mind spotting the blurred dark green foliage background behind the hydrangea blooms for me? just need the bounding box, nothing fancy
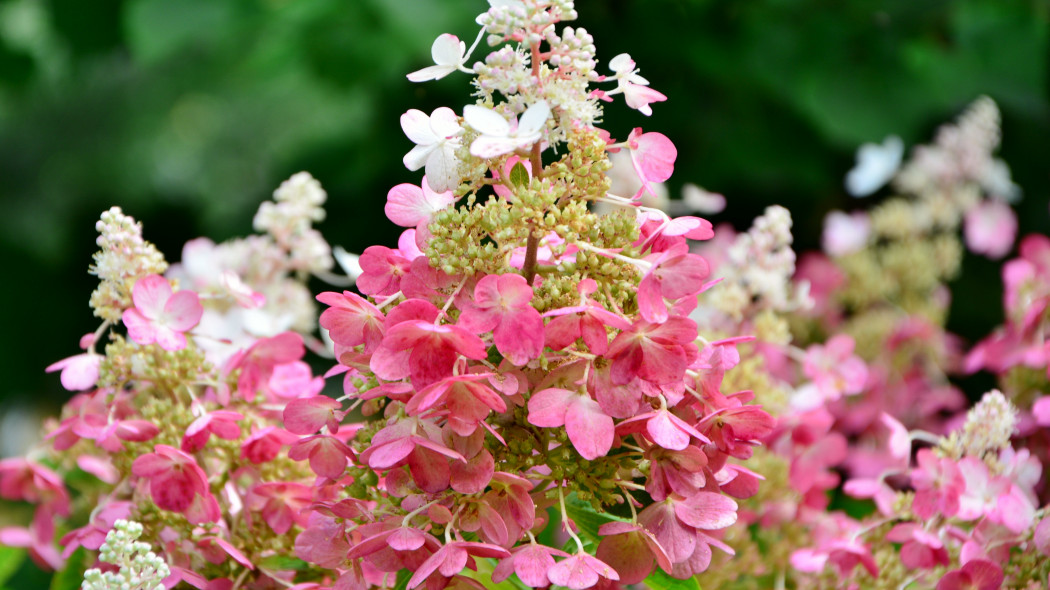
[0,0,1050,447]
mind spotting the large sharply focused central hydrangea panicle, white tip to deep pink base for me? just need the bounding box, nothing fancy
[296,2,772,588]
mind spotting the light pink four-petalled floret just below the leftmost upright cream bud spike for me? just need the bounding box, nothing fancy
[122,274,204,351]
